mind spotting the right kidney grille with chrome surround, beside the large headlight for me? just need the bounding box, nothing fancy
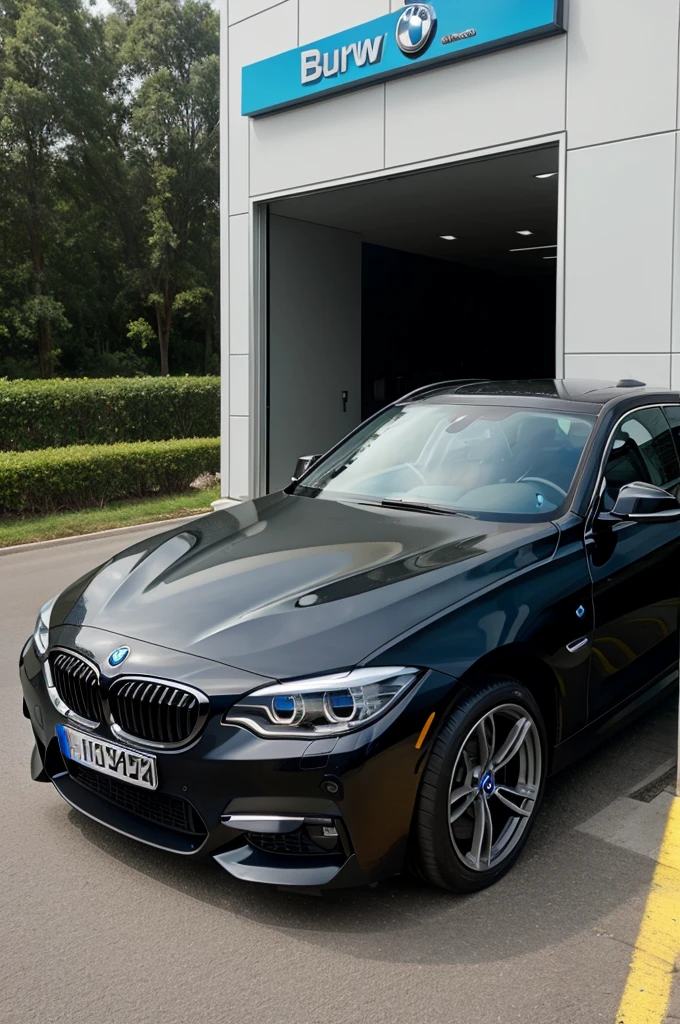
[105,676,210,751]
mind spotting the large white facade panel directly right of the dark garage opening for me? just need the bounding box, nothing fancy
[565,134,676,356]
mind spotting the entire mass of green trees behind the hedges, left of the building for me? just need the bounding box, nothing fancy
[0,0,219,377]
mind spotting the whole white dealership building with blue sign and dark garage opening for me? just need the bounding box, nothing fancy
[216,0,680,499]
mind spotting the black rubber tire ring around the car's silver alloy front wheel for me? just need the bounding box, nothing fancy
[417,676,548,892]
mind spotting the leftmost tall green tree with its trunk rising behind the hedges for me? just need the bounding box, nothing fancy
[0,0,113,377]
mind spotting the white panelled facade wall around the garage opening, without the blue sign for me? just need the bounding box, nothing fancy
[222,0,680,496]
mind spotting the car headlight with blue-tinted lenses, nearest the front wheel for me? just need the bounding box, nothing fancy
[222,667,420,738]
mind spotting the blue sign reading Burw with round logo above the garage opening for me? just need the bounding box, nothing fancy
[242,0,564,117]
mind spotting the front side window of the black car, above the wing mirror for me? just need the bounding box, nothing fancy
[603,409,680,512]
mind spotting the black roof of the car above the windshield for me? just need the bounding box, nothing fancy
[400,378,680,414]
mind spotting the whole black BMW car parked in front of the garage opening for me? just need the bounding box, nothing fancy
[20,381,680,892]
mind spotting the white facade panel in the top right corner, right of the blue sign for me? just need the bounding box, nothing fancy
[567,0,680,148]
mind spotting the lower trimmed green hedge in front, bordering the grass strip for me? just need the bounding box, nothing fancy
[0,438,219,514]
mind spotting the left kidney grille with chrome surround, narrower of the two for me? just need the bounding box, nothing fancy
[43,647,103,729]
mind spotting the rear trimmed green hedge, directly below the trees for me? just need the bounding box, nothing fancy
[0,377,220,452]
